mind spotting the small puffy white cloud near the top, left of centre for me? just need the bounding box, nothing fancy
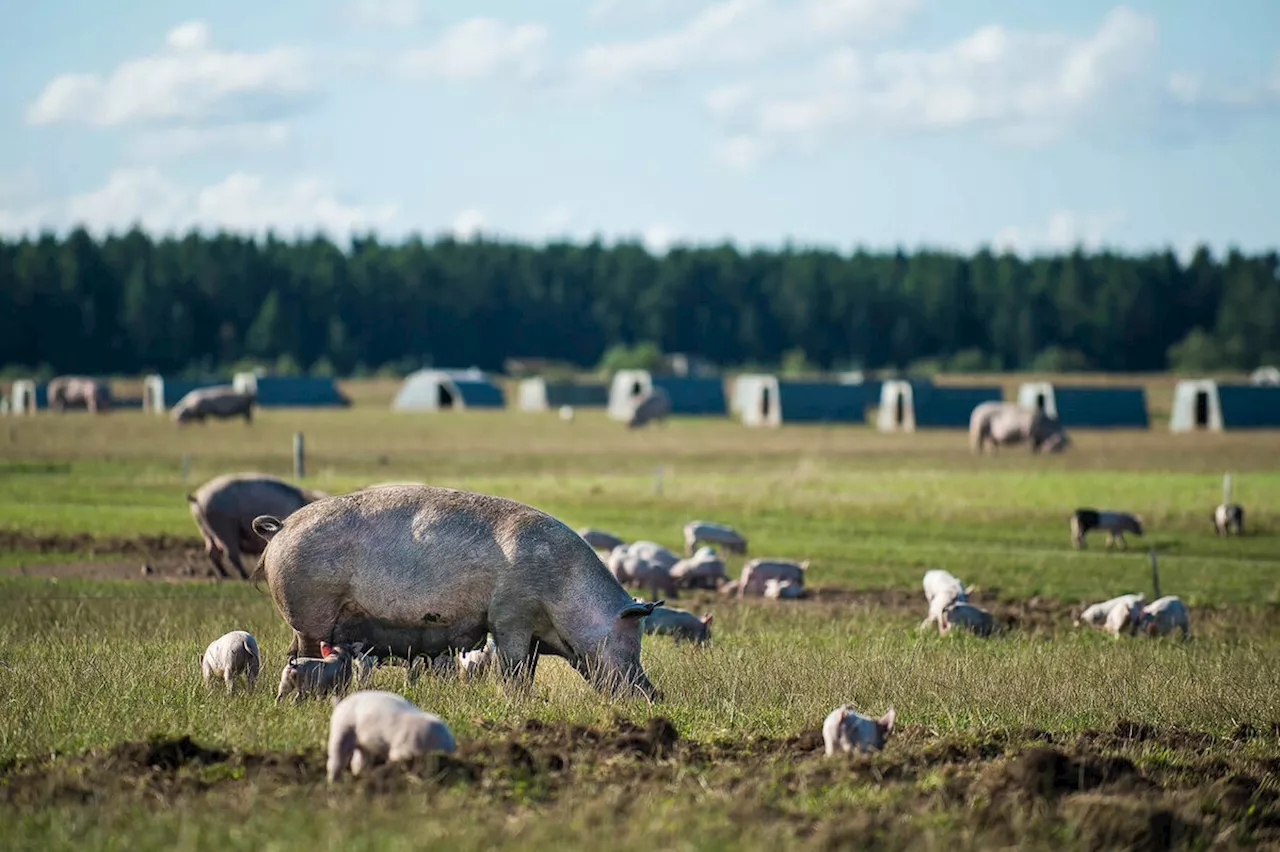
[399,18,548,79]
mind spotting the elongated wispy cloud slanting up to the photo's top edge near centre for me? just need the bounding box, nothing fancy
[571,0,918,87]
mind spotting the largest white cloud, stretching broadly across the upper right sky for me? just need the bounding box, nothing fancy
[705,6,1156,168]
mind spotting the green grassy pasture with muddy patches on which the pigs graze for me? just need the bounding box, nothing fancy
[0,384,1280,849]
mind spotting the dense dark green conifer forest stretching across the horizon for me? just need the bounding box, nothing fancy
[0,230,1280,375]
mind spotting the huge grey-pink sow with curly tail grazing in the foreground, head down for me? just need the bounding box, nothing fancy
[253,485,662,700]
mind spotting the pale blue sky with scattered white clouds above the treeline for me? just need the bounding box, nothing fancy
[0,0,1280,253]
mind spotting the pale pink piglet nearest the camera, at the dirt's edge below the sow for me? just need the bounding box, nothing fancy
[326,690,456,782]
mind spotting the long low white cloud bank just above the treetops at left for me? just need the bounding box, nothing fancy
[0,168,398,239]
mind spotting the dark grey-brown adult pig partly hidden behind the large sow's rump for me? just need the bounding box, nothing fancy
[187,473,326,580]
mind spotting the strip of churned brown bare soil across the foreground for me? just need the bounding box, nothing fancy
[0,716,1280,848]
